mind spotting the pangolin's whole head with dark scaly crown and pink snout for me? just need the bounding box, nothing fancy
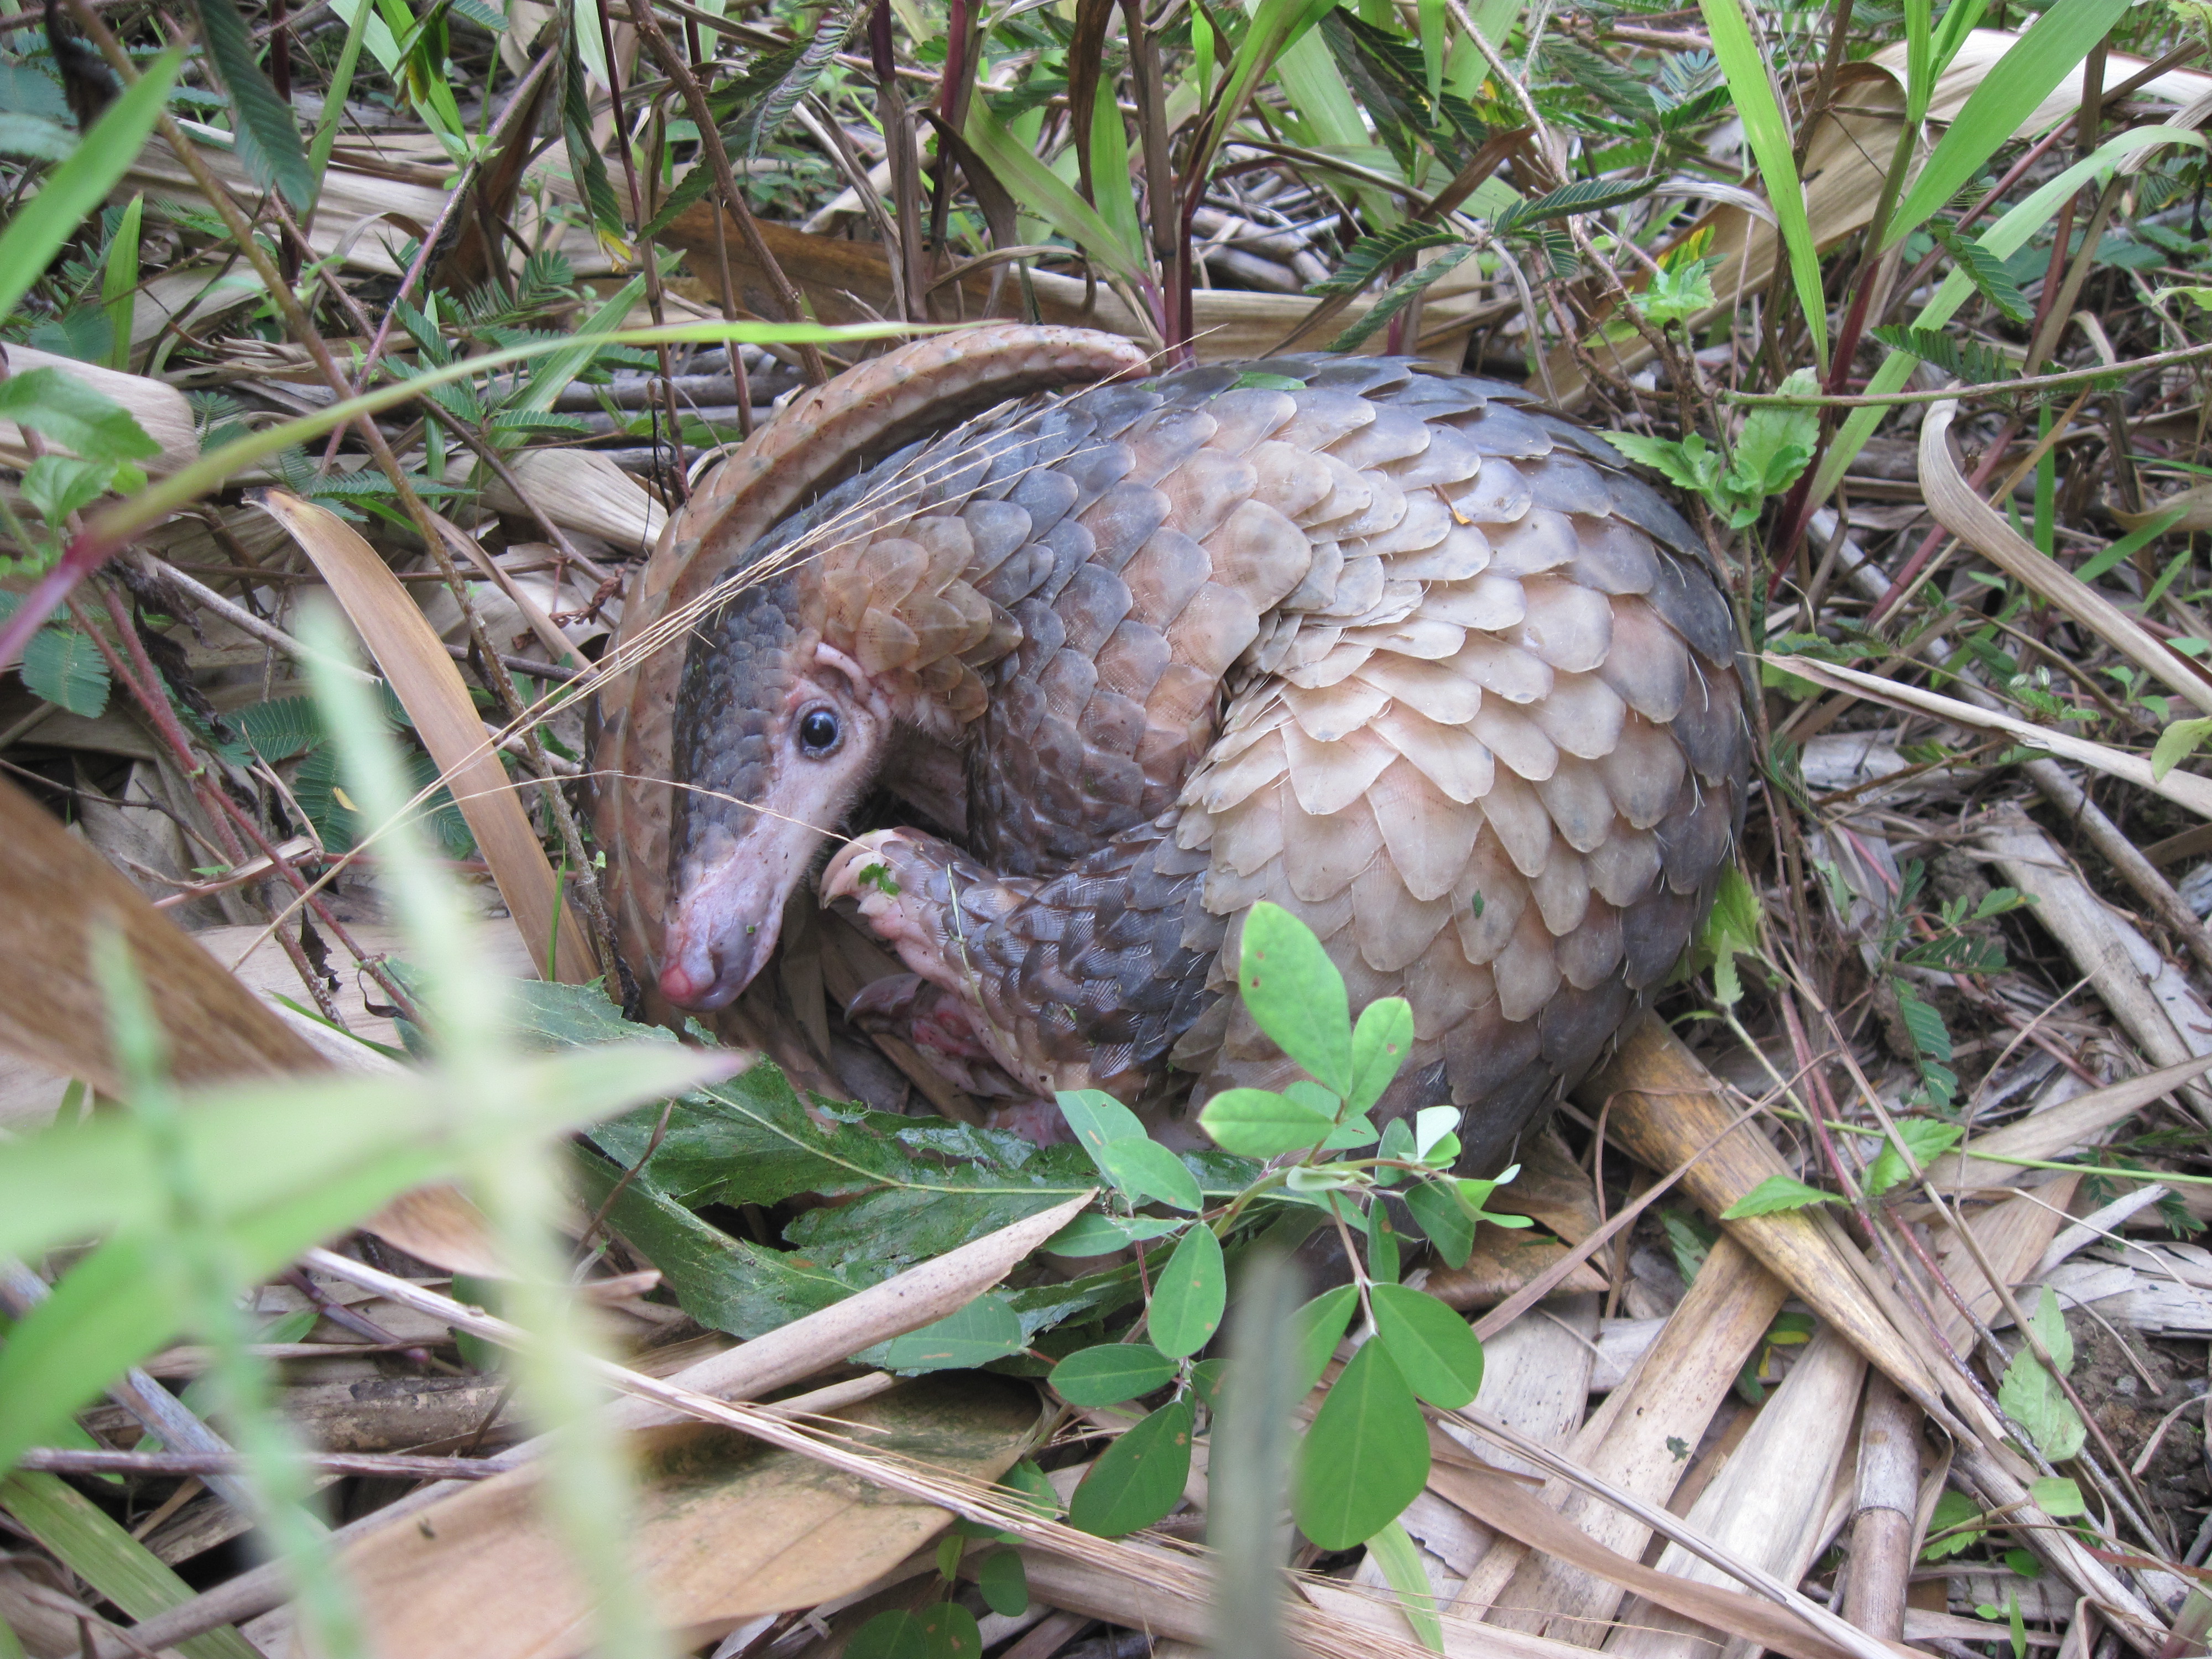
[661,566,894,1011]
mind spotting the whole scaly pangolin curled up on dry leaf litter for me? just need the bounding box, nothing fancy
[595,325,1750,1166]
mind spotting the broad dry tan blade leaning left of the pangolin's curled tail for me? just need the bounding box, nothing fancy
[261,489,599,984]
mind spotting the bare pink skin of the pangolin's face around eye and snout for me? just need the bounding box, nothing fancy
[659,644,898,1013]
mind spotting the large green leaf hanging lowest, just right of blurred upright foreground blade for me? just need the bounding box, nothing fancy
[1292,1340,1429,1551]
